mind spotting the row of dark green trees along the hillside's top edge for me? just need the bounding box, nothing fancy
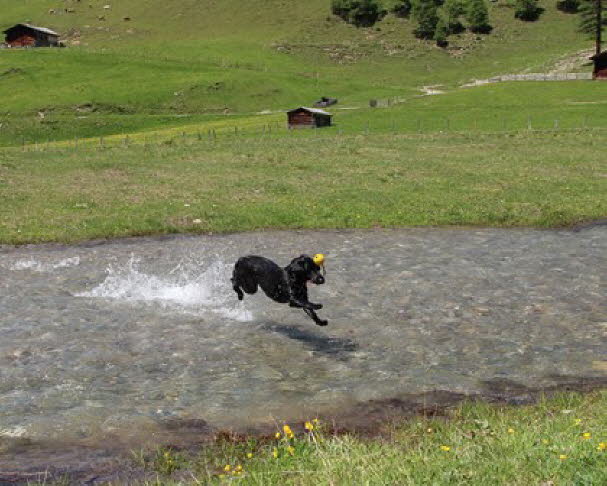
[331,0,607,46]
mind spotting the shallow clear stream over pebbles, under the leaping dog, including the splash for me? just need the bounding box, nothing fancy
[0,227,607,470]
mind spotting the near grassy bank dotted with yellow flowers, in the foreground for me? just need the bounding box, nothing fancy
[124,391,607,486]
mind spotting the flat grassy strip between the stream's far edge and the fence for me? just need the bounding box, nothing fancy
[0,130,607,244]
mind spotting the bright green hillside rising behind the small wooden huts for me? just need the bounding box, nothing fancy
[0,0,587,145]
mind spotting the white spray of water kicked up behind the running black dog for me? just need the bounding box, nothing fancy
[76,257,252,322]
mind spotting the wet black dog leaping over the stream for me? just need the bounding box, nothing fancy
[232,255,327,326]
